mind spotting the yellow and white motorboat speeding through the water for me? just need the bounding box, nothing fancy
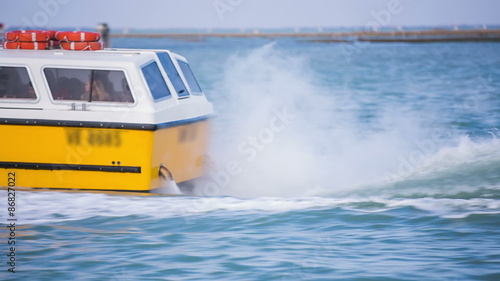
[0,30,214,192]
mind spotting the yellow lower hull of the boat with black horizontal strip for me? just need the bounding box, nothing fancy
[0,119,211,192]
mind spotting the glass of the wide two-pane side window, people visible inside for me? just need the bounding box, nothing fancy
[44,68,134,103]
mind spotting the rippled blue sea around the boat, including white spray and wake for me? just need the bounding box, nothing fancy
[0,38,500,281]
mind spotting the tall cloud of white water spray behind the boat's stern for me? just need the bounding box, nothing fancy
[197,44,500,197]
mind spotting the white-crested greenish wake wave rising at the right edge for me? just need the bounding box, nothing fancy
[355,137,500,199]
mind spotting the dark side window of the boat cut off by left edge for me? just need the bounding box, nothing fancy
[0,66,36,100]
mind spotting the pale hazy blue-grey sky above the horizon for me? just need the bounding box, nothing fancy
[0,0,500,30]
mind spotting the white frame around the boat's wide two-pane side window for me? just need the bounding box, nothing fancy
[40,64,138,107]
